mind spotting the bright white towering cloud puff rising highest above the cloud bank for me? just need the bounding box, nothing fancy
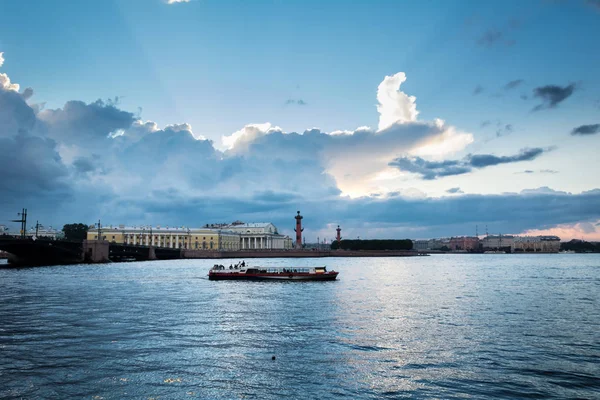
[377,72,419,131]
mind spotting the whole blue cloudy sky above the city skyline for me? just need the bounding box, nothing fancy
[0,0,600,241]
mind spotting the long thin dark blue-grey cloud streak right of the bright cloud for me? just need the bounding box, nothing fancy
[390,147,548,180]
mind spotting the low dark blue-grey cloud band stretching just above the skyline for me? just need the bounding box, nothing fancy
[116,188,600,238]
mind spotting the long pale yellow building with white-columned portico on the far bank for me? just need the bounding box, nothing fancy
[87,223,292,251]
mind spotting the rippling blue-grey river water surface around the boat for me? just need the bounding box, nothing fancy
[0,255,600,399]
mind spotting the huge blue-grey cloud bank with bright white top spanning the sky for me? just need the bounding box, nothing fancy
[0,52,600,237]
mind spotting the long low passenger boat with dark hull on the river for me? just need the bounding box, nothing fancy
[208,265,339,281]
